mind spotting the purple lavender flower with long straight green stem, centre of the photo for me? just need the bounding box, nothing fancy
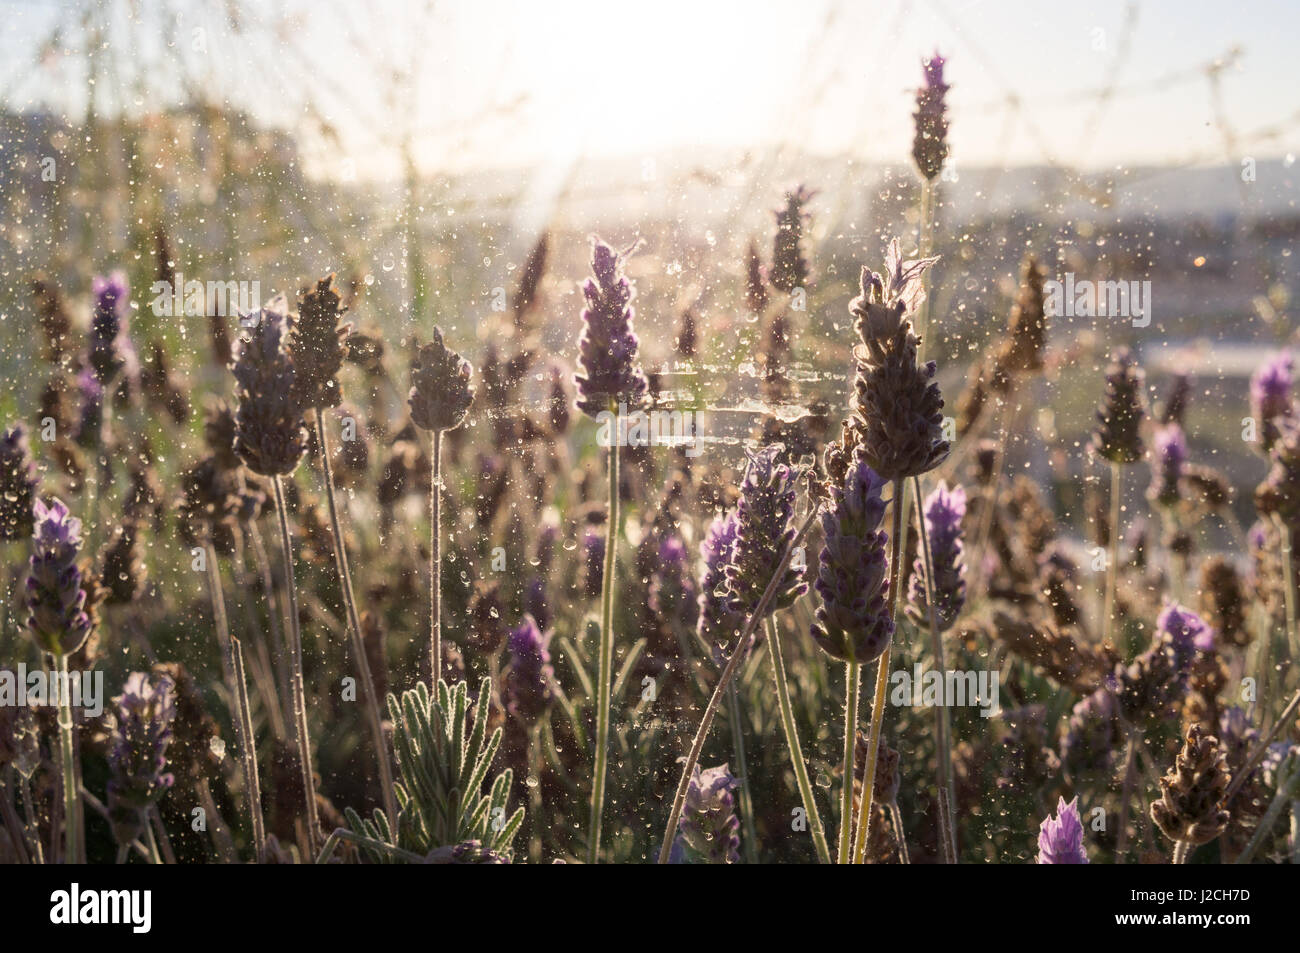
[573,239,650,863]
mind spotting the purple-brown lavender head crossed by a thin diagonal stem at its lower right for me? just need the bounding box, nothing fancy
[725,445,807,615]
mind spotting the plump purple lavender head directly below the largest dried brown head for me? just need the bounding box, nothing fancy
[811,460,894,663]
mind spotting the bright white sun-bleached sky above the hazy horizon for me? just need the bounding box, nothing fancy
[0,0,1300,174]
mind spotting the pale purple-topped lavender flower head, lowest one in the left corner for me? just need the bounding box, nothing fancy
[108,672,176,844]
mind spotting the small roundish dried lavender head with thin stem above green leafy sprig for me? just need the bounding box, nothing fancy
[408,328,475,685]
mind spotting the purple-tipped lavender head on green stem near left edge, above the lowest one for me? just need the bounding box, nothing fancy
[27,499,91,657]
